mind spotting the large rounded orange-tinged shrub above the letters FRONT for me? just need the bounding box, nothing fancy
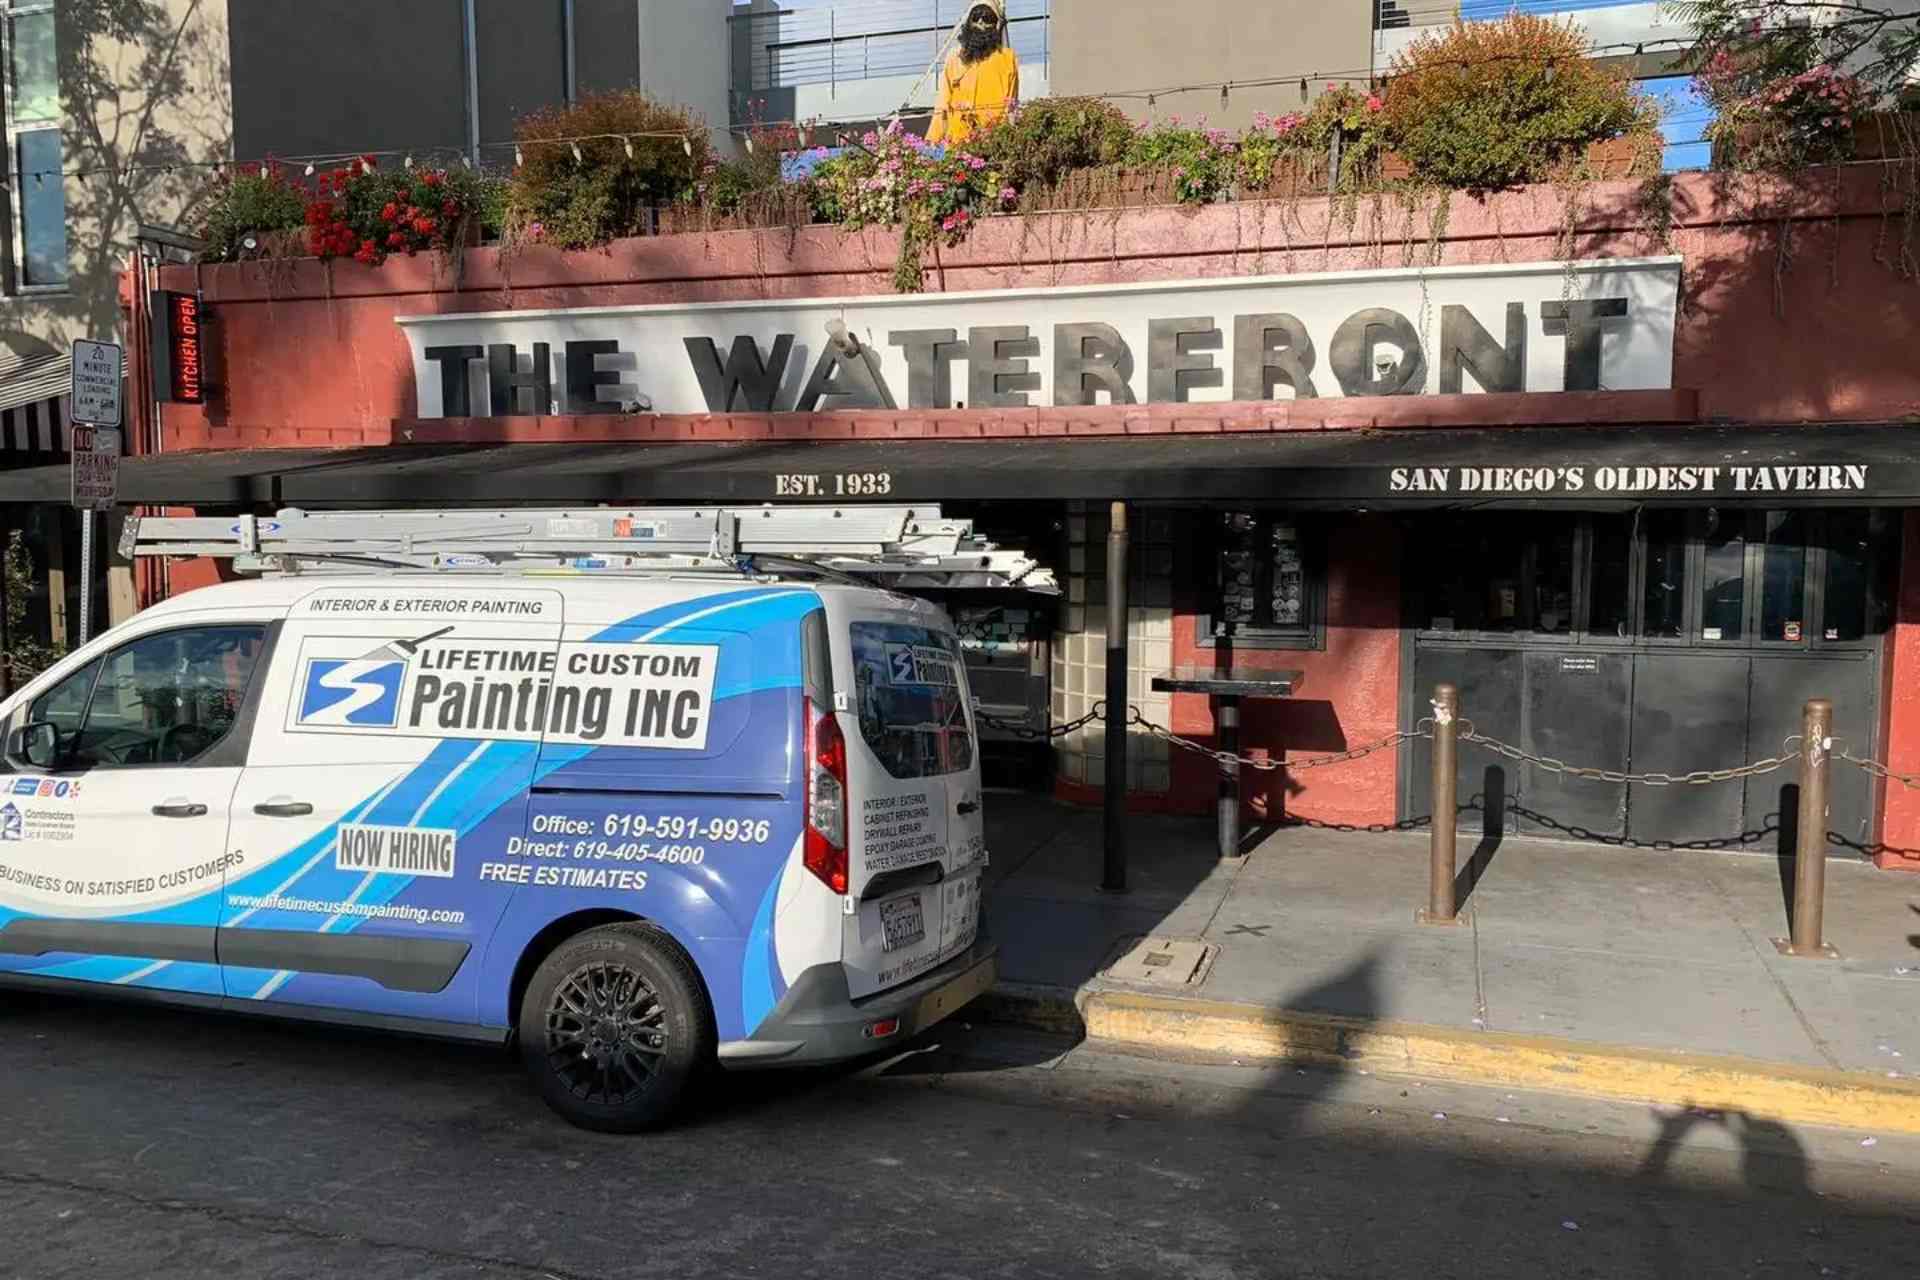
[1382,13,1659,190]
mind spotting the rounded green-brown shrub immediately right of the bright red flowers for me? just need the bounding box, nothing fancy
[505,90,712,249]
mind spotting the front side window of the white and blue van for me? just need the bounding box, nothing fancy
[50,626,267,768]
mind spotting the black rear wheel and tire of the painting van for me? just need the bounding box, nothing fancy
[518,923,714,1134]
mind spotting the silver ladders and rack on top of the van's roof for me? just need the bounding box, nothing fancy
[121,505,1058,593]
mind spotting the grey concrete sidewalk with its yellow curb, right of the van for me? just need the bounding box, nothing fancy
[985,794,1920,1132]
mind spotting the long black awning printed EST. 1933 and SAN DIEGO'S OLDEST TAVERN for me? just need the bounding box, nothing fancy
[0,424,1920,509]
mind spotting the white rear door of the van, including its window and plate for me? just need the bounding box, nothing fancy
[843,612,981,998]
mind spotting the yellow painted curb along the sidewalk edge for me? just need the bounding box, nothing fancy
[1006,990,1920,1134]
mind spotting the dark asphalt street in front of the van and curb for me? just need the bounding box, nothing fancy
[0,996,1920,1280]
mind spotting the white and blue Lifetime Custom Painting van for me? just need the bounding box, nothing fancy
[0,510,1021,1130]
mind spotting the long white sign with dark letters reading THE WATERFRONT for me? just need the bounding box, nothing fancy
[399,257,1680,418]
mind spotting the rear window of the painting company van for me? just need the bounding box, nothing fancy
[851,622,973,777]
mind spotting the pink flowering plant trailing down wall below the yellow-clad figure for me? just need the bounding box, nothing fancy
[810,121,1020,294]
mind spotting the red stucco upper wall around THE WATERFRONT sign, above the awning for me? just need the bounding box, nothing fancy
[165,165,1920,449]
